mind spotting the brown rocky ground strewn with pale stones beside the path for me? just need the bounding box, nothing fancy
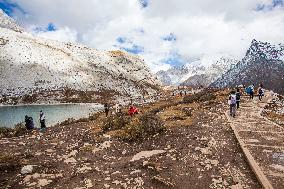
[0,91,266,189]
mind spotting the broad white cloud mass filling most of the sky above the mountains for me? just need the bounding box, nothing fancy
[10,0,284,72]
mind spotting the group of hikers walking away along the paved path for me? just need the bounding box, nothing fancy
[228,84,264,117]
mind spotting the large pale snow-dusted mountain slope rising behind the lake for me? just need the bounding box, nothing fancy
[0,12,159,103]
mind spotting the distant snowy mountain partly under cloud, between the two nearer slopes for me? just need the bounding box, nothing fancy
[156,57,237,86]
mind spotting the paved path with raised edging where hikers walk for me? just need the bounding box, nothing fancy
[226,94,284,189]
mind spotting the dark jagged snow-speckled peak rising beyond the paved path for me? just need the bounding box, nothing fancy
[211,39,284,93]
